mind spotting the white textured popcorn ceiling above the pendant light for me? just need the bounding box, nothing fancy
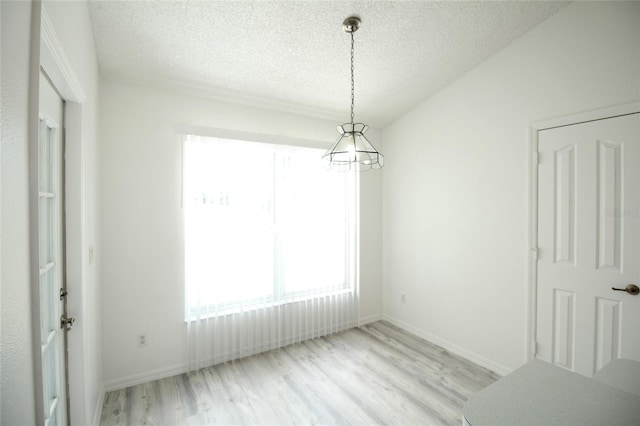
[89,0,566,128]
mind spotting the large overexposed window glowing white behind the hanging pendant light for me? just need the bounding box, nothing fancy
[184,136,357,317]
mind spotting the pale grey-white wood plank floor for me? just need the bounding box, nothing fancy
[101,321,499,426]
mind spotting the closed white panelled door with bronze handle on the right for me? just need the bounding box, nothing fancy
[536,114,640,377]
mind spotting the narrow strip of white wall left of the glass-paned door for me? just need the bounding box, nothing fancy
[0,1,36,425]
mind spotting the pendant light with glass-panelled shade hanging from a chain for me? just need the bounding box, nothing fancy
[322,16,384,171]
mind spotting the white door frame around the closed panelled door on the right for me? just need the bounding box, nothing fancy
[525,101,640,361]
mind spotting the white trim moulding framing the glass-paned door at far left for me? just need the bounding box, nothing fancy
[36,1,89,424]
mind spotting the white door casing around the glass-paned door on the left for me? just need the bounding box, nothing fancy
[29,2,88,424]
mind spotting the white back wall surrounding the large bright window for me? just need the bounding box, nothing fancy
[100,81,382,388]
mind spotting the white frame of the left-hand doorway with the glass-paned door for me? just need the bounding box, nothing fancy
[29,2,86,424]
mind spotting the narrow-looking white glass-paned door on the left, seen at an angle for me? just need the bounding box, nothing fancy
[38,73,67,426]
